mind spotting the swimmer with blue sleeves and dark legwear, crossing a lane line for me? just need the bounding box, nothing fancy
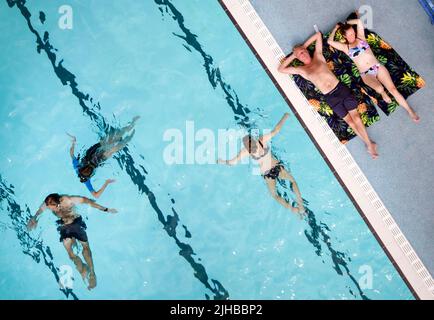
[68,116,140,198]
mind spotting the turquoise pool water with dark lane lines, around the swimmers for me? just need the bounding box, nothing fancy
[0,0,413,299]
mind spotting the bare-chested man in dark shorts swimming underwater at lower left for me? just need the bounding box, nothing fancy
[27,193,117,290]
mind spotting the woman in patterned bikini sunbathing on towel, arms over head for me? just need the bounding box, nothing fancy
[328,19,420,123]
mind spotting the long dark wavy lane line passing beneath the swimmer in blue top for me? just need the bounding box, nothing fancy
[6,0,229,300]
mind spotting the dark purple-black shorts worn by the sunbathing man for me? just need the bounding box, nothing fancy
[324,82,358,119]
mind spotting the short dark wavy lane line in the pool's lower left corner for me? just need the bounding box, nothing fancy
[0,174,79,300]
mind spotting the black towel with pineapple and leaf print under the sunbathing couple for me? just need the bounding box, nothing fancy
[292,23,425,143]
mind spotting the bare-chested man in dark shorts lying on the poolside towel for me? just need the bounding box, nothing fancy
[279,32,378,159]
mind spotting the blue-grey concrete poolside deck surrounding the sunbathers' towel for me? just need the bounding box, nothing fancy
[250,0,434,275]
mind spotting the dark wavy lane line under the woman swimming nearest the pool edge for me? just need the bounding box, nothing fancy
[154,0,369,299]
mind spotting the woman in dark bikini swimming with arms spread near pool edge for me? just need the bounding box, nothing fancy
[218,113,305,217]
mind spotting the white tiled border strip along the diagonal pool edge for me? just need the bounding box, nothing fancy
[222,0,434,300]
